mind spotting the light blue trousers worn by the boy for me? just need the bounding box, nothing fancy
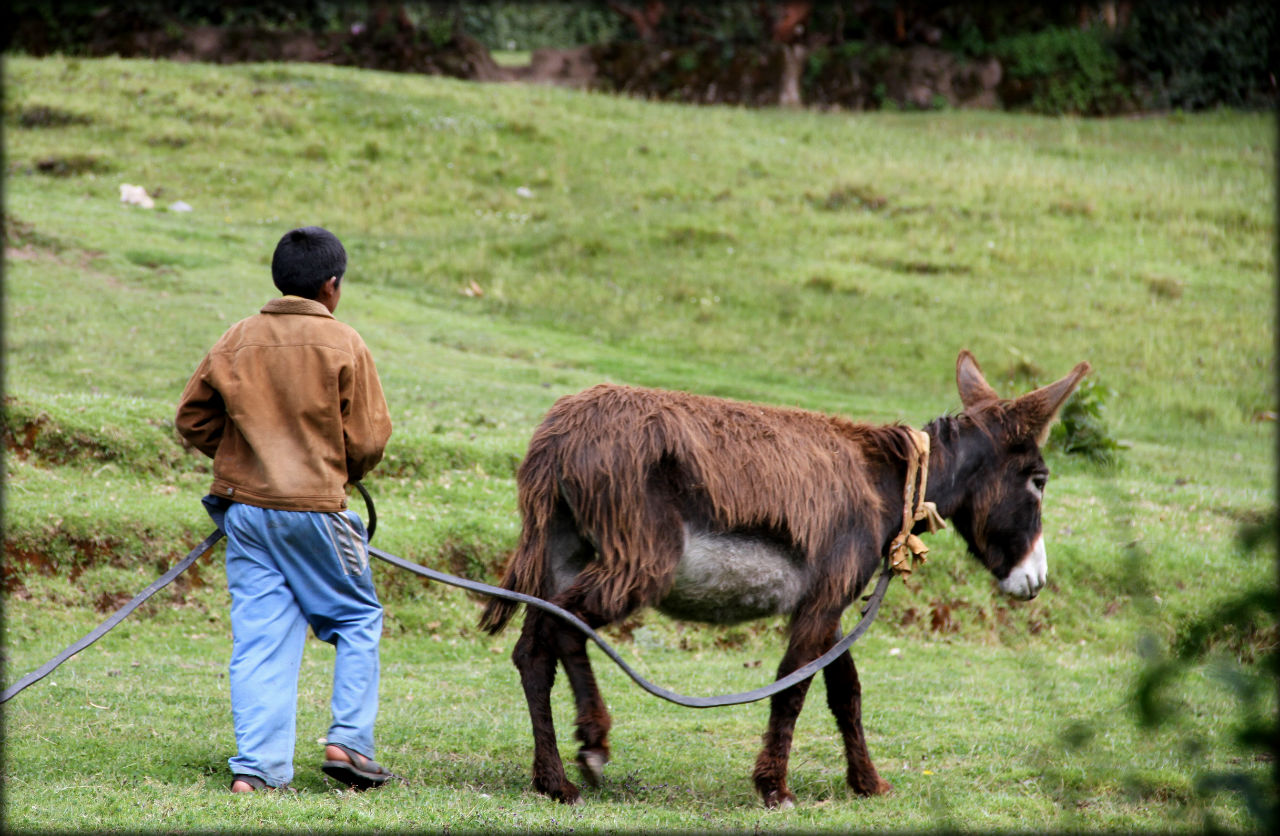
[223,503,383,786]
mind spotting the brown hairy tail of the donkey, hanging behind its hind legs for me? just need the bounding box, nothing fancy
[480,451,559,634]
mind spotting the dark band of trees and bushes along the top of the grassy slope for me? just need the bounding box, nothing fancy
[4,0,1277,117]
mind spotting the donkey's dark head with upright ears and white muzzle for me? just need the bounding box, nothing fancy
[925,351,1089,600]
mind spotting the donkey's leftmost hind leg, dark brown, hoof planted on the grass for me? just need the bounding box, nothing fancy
[511,608,581,804]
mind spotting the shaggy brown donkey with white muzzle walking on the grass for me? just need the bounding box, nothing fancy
[480,351,1091,808]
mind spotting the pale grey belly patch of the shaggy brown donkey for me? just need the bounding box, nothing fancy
[658,527,809,623]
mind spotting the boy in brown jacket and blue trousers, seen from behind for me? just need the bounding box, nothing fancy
[175,227,394,792]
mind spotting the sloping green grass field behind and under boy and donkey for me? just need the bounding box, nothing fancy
[4,58,1277,831]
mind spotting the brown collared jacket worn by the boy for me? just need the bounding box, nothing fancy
[175,296,392,511]
